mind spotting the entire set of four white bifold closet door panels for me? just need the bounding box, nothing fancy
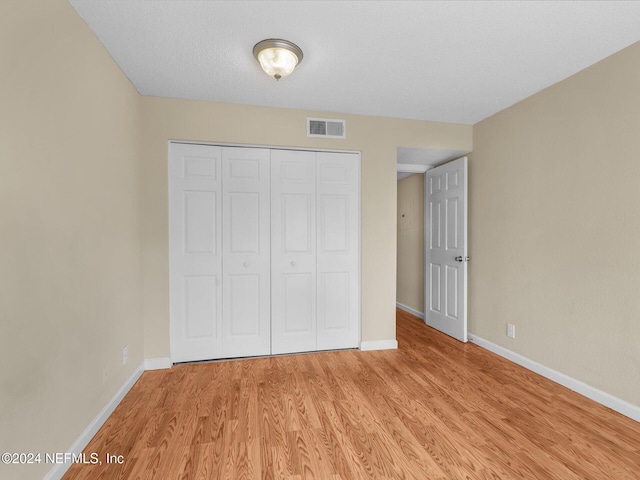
[169,143,360,362]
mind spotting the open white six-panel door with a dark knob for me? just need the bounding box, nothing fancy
[425,157,469,342]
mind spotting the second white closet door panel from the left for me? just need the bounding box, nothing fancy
[222,147,271,358]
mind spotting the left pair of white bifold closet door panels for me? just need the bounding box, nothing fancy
[169,143,271,362]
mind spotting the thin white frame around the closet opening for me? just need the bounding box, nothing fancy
[165,139,362,364]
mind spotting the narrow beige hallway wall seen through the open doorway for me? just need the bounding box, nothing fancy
[396,173,424,313]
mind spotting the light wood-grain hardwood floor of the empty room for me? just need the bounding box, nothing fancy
[64,311,640,480]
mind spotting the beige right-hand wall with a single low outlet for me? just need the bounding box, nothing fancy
[469,44,640,406]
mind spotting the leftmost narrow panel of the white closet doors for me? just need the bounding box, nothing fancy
[169,143,222,362]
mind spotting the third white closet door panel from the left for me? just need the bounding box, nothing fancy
[271,150,317,354]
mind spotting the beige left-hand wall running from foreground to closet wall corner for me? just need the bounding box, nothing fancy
[0,0,143,479]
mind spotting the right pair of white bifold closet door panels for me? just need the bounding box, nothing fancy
[271,150,360,354]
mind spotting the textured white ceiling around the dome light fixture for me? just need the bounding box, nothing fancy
[70,0,640,124]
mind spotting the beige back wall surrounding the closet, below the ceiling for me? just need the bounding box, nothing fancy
[141,97,471,358]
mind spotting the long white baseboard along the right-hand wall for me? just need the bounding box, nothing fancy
[469,334,640,422]
